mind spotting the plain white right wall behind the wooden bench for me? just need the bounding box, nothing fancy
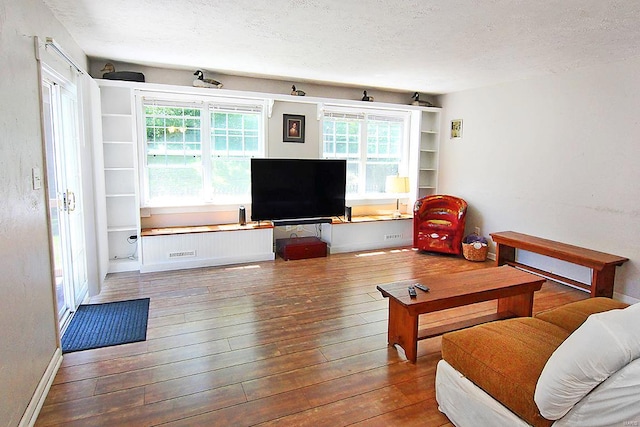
[439,58,640,299]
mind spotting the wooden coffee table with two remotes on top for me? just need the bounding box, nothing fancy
[377,266,545,363]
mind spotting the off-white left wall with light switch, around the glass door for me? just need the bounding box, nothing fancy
[0,0,85,426]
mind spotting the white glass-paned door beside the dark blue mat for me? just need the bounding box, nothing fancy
[42,68,87,329]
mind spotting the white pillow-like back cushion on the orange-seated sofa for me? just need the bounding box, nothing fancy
[534,304,640,420]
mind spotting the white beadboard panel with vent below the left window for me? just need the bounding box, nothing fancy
[140,228,275,272]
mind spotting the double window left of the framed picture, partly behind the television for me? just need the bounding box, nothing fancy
[142,98,264,206]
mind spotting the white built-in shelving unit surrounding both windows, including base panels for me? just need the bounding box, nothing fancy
[98,80,441,273]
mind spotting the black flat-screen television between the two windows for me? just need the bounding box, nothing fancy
[251,159,347,221]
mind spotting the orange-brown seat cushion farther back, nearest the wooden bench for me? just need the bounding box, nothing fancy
[536,297,629,333]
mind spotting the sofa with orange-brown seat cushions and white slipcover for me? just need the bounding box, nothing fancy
[436,298,640,427]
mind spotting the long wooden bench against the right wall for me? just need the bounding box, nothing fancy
[491,231,629,298]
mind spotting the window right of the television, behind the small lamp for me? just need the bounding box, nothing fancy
[322,109,409,198]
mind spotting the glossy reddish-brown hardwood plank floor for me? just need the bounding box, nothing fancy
[36,248,588,426]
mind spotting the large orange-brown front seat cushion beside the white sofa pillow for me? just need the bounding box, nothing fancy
[442,317,569,426]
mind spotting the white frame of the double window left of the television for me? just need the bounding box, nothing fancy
[135,90,269,209]
